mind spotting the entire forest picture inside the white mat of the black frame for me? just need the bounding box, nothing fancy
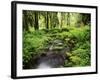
[22,10,91,69]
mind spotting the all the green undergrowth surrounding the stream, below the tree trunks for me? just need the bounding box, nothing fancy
[23,26,91,67]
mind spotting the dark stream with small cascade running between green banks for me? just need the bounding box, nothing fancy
[24,39,69,69]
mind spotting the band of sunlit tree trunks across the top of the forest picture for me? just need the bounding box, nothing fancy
[23,10,91,31]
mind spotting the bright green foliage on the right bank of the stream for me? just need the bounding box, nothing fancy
[65,26,91,67]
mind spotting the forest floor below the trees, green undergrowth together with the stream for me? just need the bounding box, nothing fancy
[23,26,91,69]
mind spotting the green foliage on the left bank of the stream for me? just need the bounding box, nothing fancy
[23,31,47,63]
